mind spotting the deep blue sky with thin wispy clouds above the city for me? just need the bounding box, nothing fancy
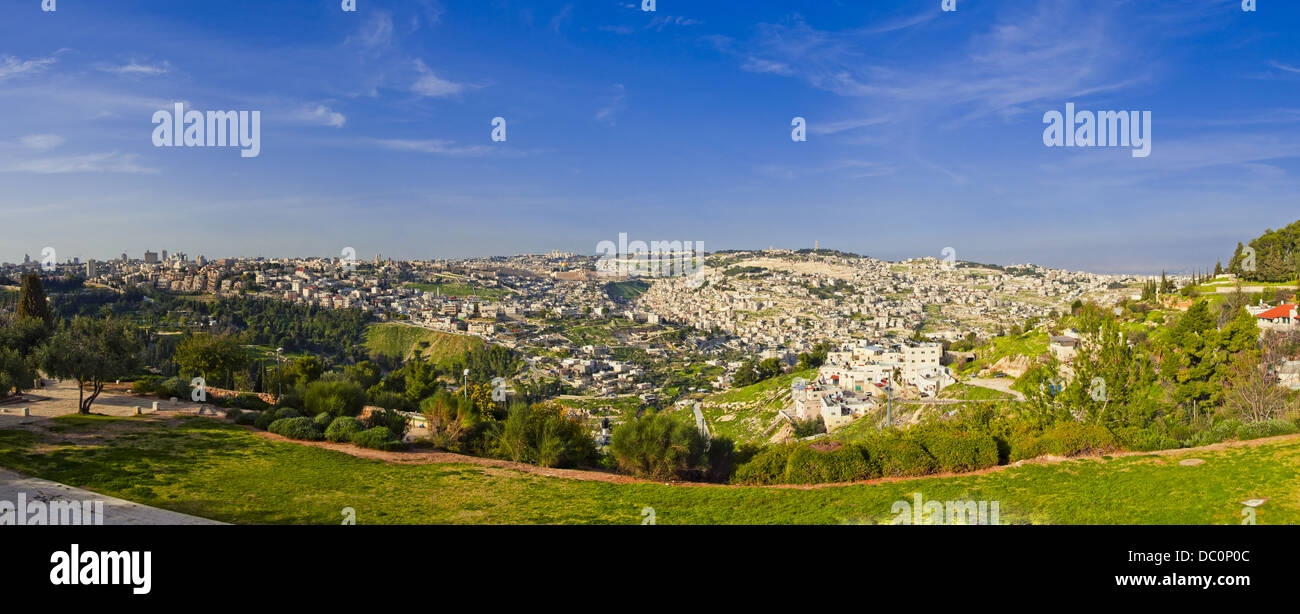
[0,0,1300,272]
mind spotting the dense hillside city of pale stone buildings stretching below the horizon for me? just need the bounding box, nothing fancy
[0,245,1147,413]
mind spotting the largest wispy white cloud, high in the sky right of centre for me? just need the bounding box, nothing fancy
[733,0,1148,120]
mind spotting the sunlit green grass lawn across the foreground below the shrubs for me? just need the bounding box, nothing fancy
[0,416,1300,524]
